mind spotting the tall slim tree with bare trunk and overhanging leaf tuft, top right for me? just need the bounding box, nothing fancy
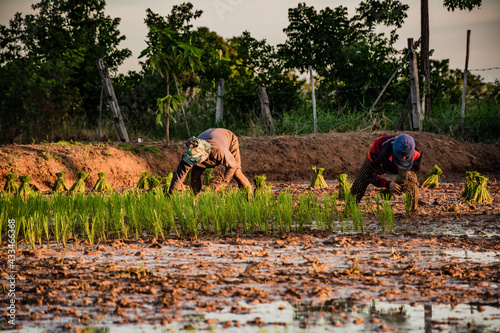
[420,0,482,115]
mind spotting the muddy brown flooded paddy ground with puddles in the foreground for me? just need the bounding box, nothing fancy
[1,181,500,332]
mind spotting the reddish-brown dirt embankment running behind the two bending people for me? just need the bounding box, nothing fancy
[0,131,500,191]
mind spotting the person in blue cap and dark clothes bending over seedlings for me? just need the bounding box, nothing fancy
[351,134,422,202]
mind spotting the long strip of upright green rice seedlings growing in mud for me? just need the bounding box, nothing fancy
[0,188,402,247]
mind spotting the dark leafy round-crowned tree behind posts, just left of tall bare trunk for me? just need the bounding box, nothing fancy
[279,0,408,112]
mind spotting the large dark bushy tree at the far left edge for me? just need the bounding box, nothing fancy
[0,0,131,140]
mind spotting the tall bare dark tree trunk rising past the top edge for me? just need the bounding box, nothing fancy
[420,0,432,115]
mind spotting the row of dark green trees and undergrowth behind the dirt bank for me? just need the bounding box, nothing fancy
[0,0,500,144]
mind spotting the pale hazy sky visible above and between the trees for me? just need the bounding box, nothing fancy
[0,0,500,81]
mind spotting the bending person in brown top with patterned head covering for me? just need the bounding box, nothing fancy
[169,128,251,194]
